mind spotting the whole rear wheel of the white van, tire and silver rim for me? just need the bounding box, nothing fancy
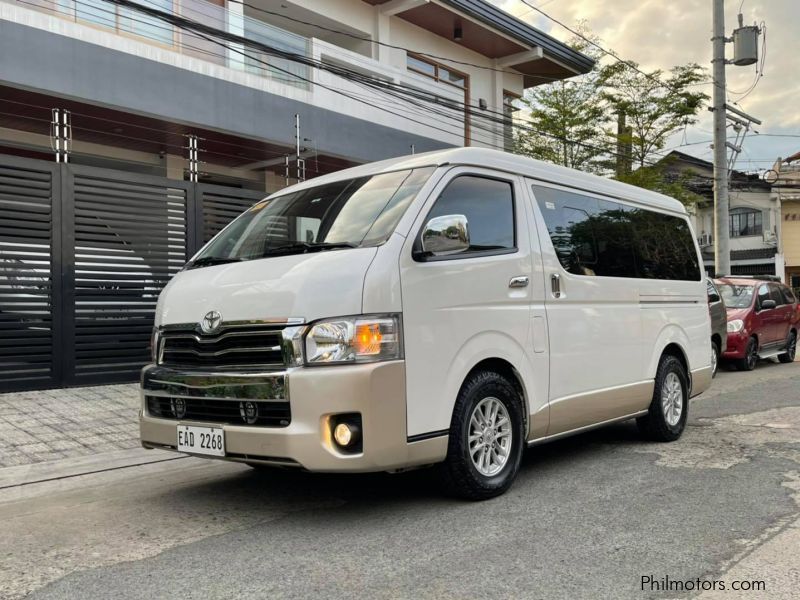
[636,354,689,442]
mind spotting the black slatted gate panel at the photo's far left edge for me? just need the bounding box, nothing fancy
[0,160,54,390]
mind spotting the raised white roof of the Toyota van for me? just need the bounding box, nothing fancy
[275,148,686,214]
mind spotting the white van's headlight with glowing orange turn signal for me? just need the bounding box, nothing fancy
[305,315,403,365]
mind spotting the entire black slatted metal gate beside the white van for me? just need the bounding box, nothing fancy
[0,155,265,391]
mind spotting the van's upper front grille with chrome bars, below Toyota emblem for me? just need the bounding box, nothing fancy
[158,322,286,370]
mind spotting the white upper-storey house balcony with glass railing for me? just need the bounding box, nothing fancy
[0,0,468,152]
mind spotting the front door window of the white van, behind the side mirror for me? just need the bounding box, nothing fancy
[427,175,516,256]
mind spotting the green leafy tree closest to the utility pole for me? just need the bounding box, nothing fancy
[598,62,708,168]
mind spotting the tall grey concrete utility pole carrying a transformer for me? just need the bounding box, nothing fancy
[711,0,731,277]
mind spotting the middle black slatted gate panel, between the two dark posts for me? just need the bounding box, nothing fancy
[73,169,187,382]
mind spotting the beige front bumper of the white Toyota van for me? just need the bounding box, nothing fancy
[139,361,447,472]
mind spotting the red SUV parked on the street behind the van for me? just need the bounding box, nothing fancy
[715,277,800,371]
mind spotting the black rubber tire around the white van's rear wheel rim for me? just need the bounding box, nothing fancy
[636,354,689,442]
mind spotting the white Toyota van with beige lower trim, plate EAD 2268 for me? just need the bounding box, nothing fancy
[141,148,711,499]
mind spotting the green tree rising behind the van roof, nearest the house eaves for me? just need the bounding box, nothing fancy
[514,24,607,171]
